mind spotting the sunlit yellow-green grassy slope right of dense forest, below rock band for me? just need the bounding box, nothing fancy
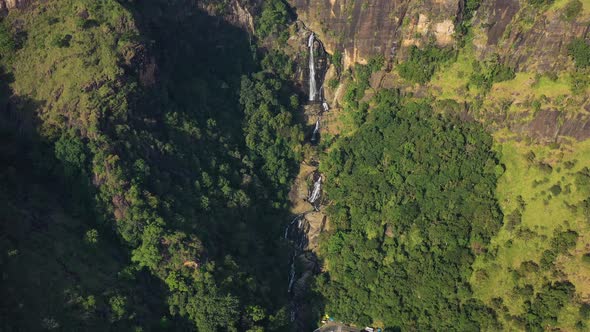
[471,141,590,328]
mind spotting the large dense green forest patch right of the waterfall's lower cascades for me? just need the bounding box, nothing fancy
[317,93,501,330]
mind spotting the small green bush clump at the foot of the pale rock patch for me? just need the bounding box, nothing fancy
[398,44,454,84]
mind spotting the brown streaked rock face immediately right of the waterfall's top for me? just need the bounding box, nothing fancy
[289,0,461,66]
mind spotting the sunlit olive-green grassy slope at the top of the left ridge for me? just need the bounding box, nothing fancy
[6,0,137,135]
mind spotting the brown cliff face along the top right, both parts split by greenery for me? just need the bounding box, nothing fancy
[288,0,589,71]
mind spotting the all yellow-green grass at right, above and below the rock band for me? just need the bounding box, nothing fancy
[429,0,590,330]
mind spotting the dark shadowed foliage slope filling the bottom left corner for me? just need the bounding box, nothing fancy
[0,128,173,331]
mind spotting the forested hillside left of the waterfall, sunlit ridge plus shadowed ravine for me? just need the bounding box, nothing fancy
[0,0,302,331]
